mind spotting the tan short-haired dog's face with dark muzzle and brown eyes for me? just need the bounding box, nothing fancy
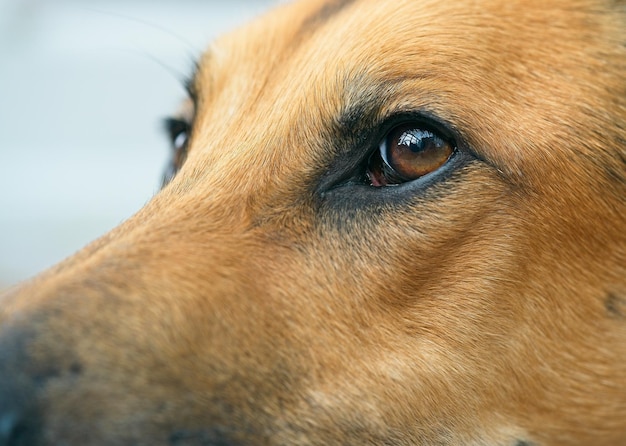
[0,0,626,446]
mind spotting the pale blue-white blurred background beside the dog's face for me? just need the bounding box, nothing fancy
[0,0,275,289]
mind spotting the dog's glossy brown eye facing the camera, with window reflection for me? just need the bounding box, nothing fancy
[367,123,455,187]
